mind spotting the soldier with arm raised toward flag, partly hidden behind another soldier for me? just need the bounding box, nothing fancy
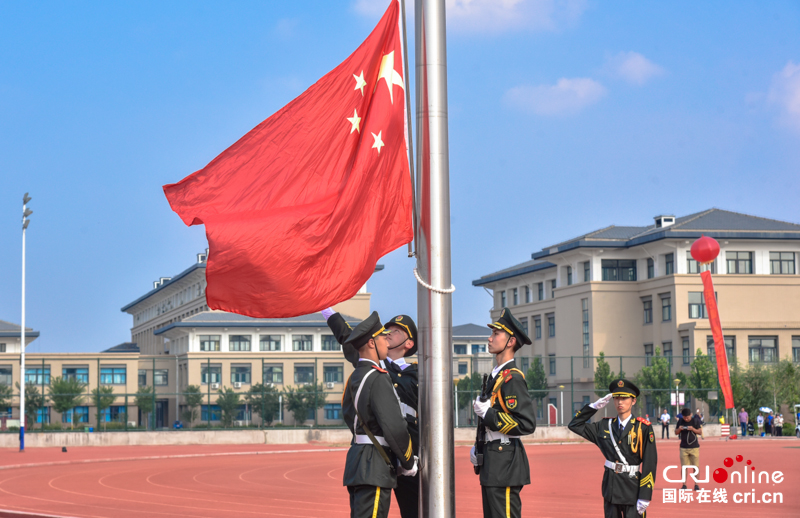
[322,309,419,518]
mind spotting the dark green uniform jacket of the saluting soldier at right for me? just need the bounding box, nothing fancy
[569,405,658,505]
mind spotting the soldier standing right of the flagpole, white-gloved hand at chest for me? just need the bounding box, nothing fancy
[470,308,536,518]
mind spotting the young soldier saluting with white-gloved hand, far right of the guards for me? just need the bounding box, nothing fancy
[569,379,658,518]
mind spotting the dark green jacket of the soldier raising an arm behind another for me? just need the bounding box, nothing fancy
[328,313,419,455]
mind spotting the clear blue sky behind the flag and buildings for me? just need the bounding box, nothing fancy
[0,0,800,352]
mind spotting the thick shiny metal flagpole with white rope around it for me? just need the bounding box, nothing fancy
[415,0,455,518]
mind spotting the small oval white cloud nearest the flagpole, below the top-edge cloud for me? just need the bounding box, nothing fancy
[504,77,606,115]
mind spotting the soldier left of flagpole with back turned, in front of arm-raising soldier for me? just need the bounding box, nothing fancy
[342,312,417,518]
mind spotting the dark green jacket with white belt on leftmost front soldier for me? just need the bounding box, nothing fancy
[342,360,414,488]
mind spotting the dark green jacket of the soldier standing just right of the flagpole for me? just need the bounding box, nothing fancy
[481,360,536,487]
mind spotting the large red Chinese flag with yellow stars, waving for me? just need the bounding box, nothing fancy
[164,1,413,318]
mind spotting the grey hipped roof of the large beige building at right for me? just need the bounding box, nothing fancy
[472,208,800,286]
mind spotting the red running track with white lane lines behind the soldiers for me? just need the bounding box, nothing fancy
[0,438,800,518]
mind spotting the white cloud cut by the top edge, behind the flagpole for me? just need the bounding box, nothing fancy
[353,0,587,33]
